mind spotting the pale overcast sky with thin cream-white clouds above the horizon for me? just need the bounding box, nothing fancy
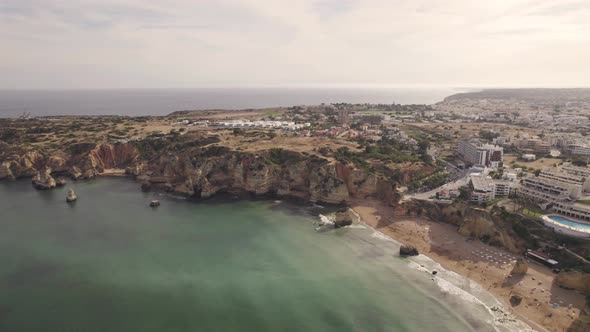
[0,0,590,89]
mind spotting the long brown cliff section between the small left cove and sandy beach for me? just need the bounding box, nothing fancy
[139,151,395,204]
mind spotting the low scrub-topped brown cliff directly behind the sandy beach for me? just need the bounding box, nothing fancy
[398,201,526,253]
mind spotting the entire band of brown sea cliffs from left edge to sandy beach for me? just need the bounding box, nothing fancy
[0,144,396,204]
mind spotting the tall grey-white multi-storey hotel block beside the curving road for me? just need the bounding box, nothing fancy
[457,138,504,168]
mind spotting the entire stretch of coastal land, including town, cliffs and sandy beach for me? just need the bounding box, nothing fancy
[0,90,590,331]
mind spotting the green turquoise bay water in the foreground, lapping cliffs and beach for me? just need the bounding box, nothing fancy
[0,179,504,332]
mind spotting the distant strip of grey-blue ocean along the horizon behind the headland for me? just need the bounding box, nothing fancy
[0,88,463,118]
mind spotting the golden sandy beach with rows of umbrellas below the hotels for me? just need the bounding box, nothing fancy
[352,200,585,331]
